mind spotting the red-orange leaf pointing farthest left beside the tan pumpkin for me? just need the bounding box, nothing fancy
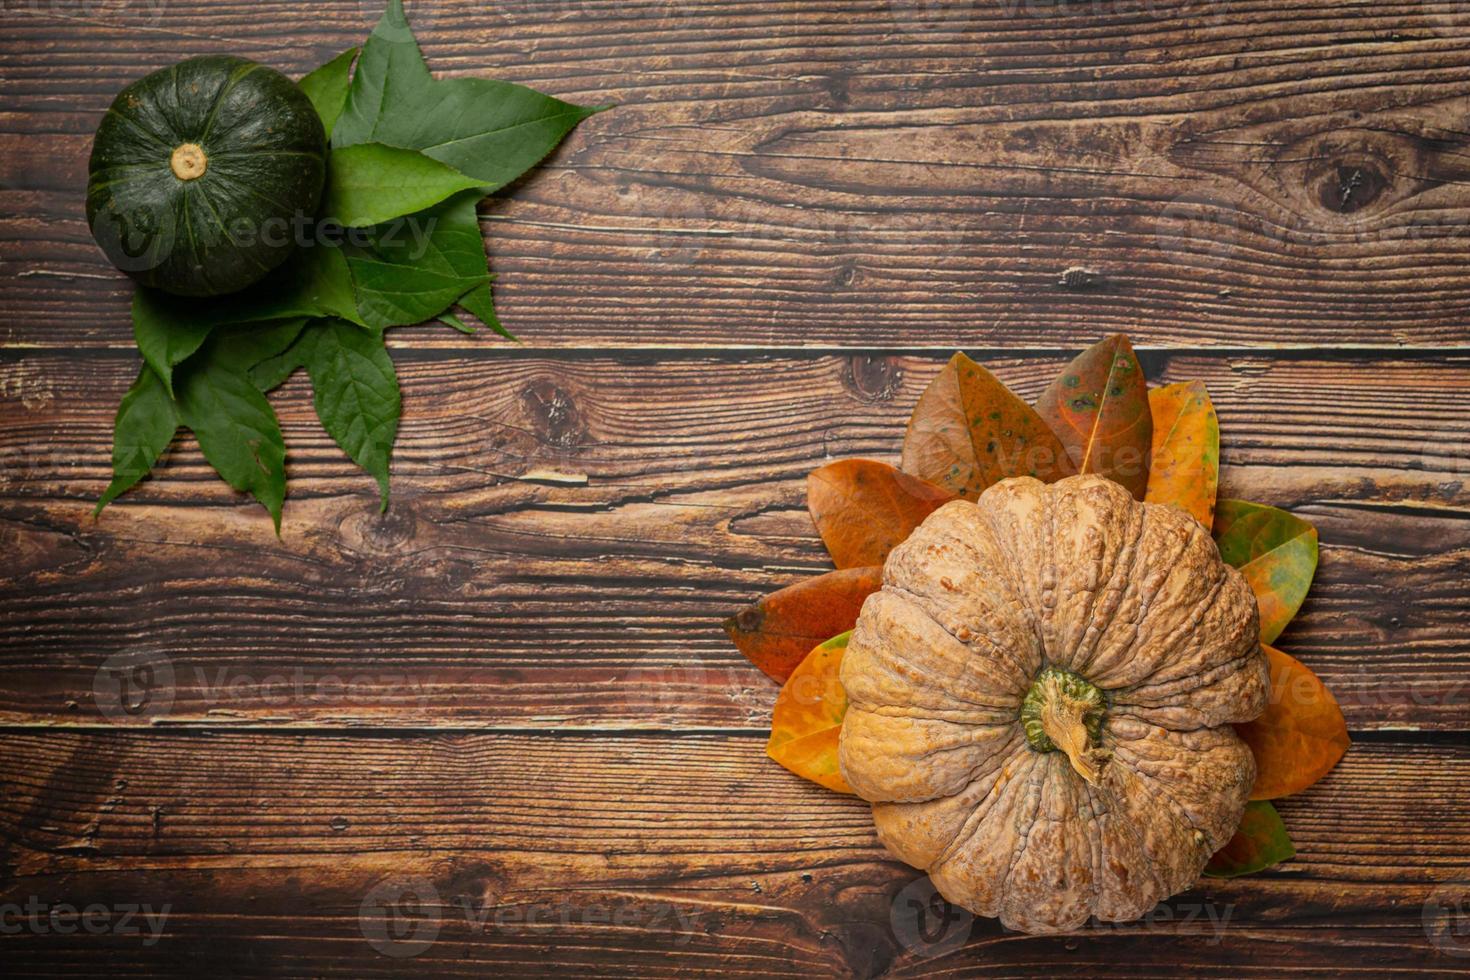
[725,566,883,682]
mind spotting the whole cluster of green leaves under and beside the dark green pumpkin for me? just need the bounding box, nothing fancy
[97,0,598,532]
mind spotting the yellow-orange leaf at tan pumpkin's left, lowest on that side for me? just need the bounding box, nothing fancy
[766,632,853,793]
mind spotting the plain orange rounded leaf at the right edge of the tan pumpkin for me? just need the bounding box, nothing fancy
[1235,644,1349,799]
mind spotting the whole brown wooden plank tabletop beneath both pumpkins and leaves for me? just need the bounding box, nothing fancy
[0,0,1470,977]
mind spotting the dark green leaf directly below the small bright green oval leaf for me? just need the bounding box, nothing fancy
[347,191,490,329]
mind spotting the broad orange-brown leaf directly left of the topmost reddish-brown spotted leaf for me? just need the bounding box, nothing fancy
[903,354,1076,500]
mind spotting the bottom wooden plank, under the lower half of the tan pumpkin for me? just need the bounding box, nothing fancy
[0,732,1470,977]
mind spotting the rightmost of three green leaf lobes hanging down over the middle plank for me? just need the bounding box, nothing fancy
[306,320,403,510]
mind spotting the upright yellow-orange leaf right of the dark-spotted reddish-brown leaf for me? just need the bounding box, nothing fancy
[1144,381,1220,527]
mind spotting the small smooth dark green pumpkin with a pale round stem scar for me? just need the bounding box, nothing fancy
[87,54,326,297]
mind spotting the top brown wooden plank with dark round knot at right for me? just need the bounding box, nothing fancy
[0,0,1470,348]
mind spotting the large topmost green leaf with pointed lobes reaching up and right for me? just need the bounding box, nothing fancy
[332,0,600,190]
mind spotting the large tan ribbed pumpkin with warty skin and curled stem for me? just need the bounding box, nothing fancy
[839,476,1269,933]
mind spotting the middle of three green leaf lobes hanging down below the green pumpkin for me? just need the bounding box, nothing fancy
[178,344,285,533]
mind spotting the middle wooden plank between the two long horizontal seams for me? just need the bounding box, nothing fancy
[0,353,1470,730]
